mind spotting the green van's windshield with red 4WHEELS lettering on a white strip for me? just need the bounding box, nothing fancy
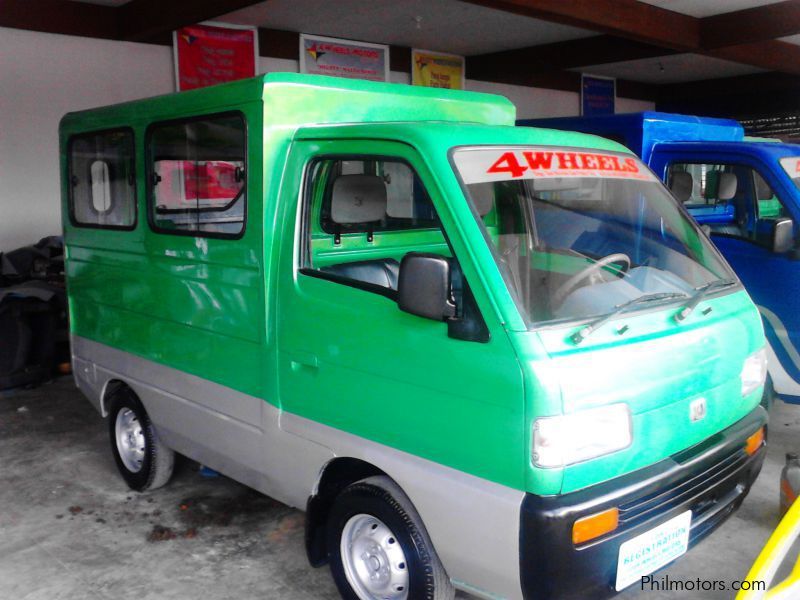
[453,147,734,324]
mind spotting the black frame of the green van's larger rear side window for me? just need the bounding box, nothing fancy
[144,110,250,240]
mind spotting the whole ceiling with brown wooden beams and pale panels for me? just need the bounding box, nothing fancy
[0,0,800,109]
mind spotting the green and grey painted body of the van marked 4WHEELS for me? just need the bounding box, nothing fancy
[60,74,765,598]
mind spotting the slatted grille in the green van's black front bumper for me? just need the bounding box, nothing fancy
[619,448,748,529]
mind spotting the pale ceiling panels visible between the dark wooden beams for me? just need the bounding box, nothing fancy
[216,0,800,84]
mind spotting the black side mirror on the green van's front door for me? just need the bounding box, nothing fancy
[397,252,456,321]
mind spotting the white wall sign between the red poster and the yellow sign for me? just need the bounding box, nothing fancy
[300,33,389,81]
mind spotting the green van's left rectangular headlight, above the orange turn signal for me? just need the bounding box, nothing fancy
[532,404,633,468]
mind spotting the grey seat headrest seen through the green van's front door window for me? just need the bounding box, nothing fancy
[331,175,387,225]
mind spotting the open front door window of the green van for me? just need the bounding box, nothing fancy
[301,157,451,293]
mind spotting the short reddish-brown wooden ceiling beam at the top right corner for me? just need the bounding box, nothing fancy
[700,0,800,49]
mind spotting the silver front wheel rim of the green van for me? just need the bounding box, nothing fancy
[339,514,408,600]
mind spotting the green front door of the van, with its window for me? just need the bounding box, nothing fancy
[277,140,526,489]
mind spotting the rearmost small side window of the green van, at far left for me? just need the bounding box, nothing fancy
[68,130,136,229]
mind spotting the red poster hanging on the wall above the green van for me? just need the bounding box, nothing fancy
[174,25,258,91]
